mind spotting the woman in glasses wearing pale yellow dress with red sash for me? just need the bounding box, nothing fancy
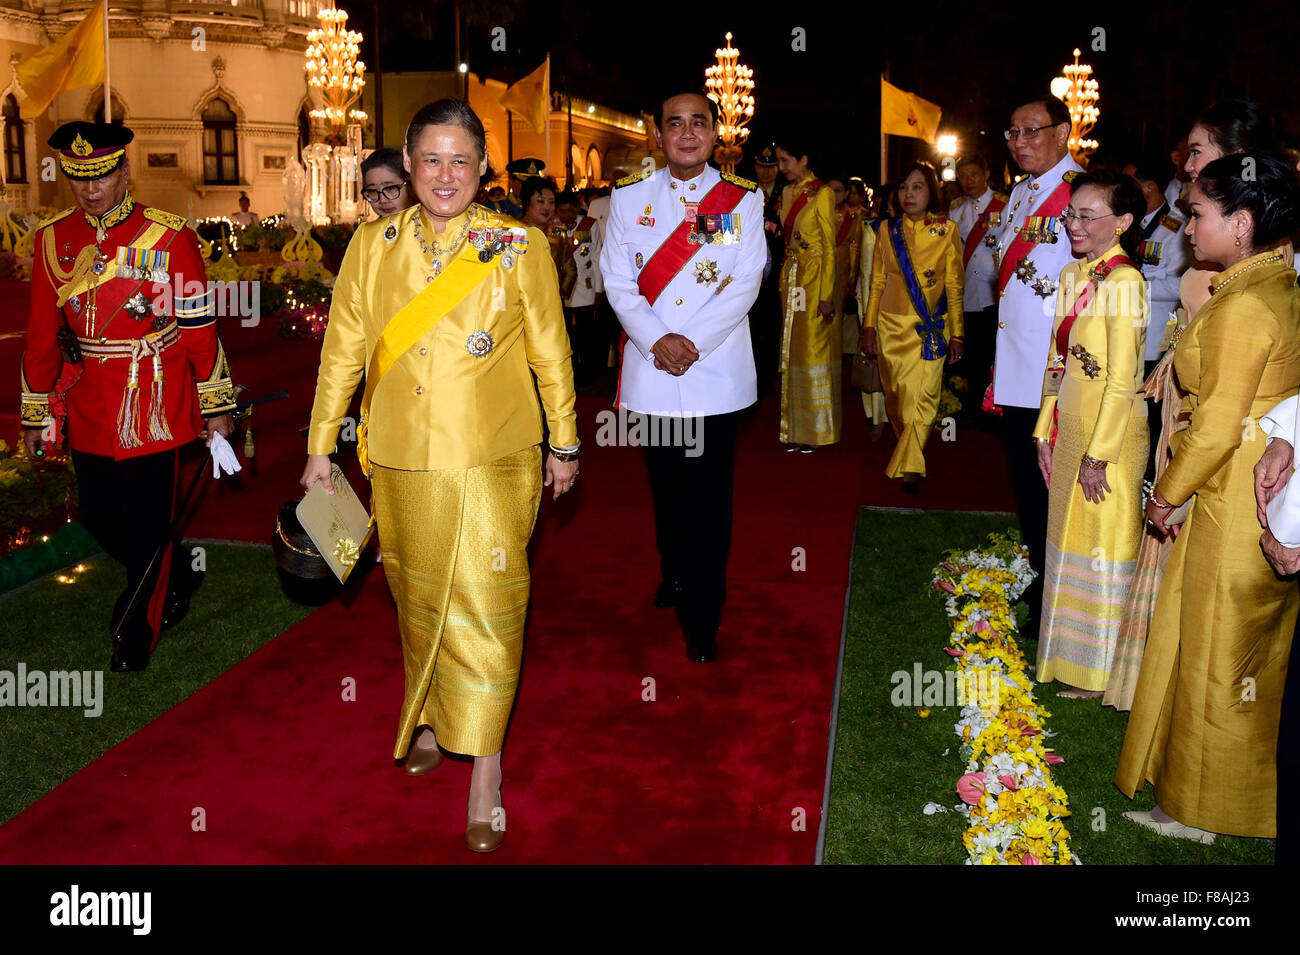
[1034,170,1151,699]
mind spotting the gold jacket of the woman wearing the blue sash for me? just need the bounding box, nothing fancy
[863,216,966,348]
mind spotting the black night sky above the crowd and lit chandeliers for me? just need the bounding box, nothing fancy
[356,0,1300,182]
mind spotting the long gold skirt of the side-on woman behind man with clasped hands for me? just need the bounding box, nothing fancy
[780,256,844,446]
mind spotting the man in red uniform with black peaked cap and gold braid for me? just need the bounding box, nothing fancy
[22,122,235,672]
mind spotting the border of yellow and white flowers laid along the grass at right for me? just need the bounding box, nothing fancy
[933,534,1078,865]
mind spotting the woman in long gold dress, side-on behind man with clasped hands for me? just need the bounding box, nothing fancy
[776,140,841,453]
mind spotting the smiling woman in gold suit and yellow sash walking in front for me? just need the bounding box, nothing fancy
[302,99,579,852]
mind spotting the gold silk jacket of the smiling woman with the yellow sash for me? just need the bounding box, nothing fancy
[307,205,577,470]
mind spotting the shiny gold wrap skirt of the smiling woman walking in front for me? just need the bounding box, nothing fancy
[372,447,542,759]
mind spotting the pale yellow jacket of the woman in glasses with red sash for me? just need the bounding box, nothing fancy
[1034,243,1147,461]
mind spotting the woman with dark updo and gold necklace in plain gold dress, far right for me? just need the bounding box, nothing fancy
[1115,153,1300,842]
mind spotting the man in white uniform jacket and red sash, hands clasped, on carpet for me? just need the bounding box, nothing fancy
[599,94,767,663]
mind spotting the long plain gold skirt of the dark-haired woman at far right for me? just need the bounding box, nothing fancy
[1115,433,1300,838]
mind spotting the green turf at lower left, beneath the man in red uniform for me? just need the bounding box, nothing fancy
[0,542,311,824]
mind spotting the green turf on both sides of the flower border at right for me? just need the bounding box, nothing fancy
[824,508,1273,865]
